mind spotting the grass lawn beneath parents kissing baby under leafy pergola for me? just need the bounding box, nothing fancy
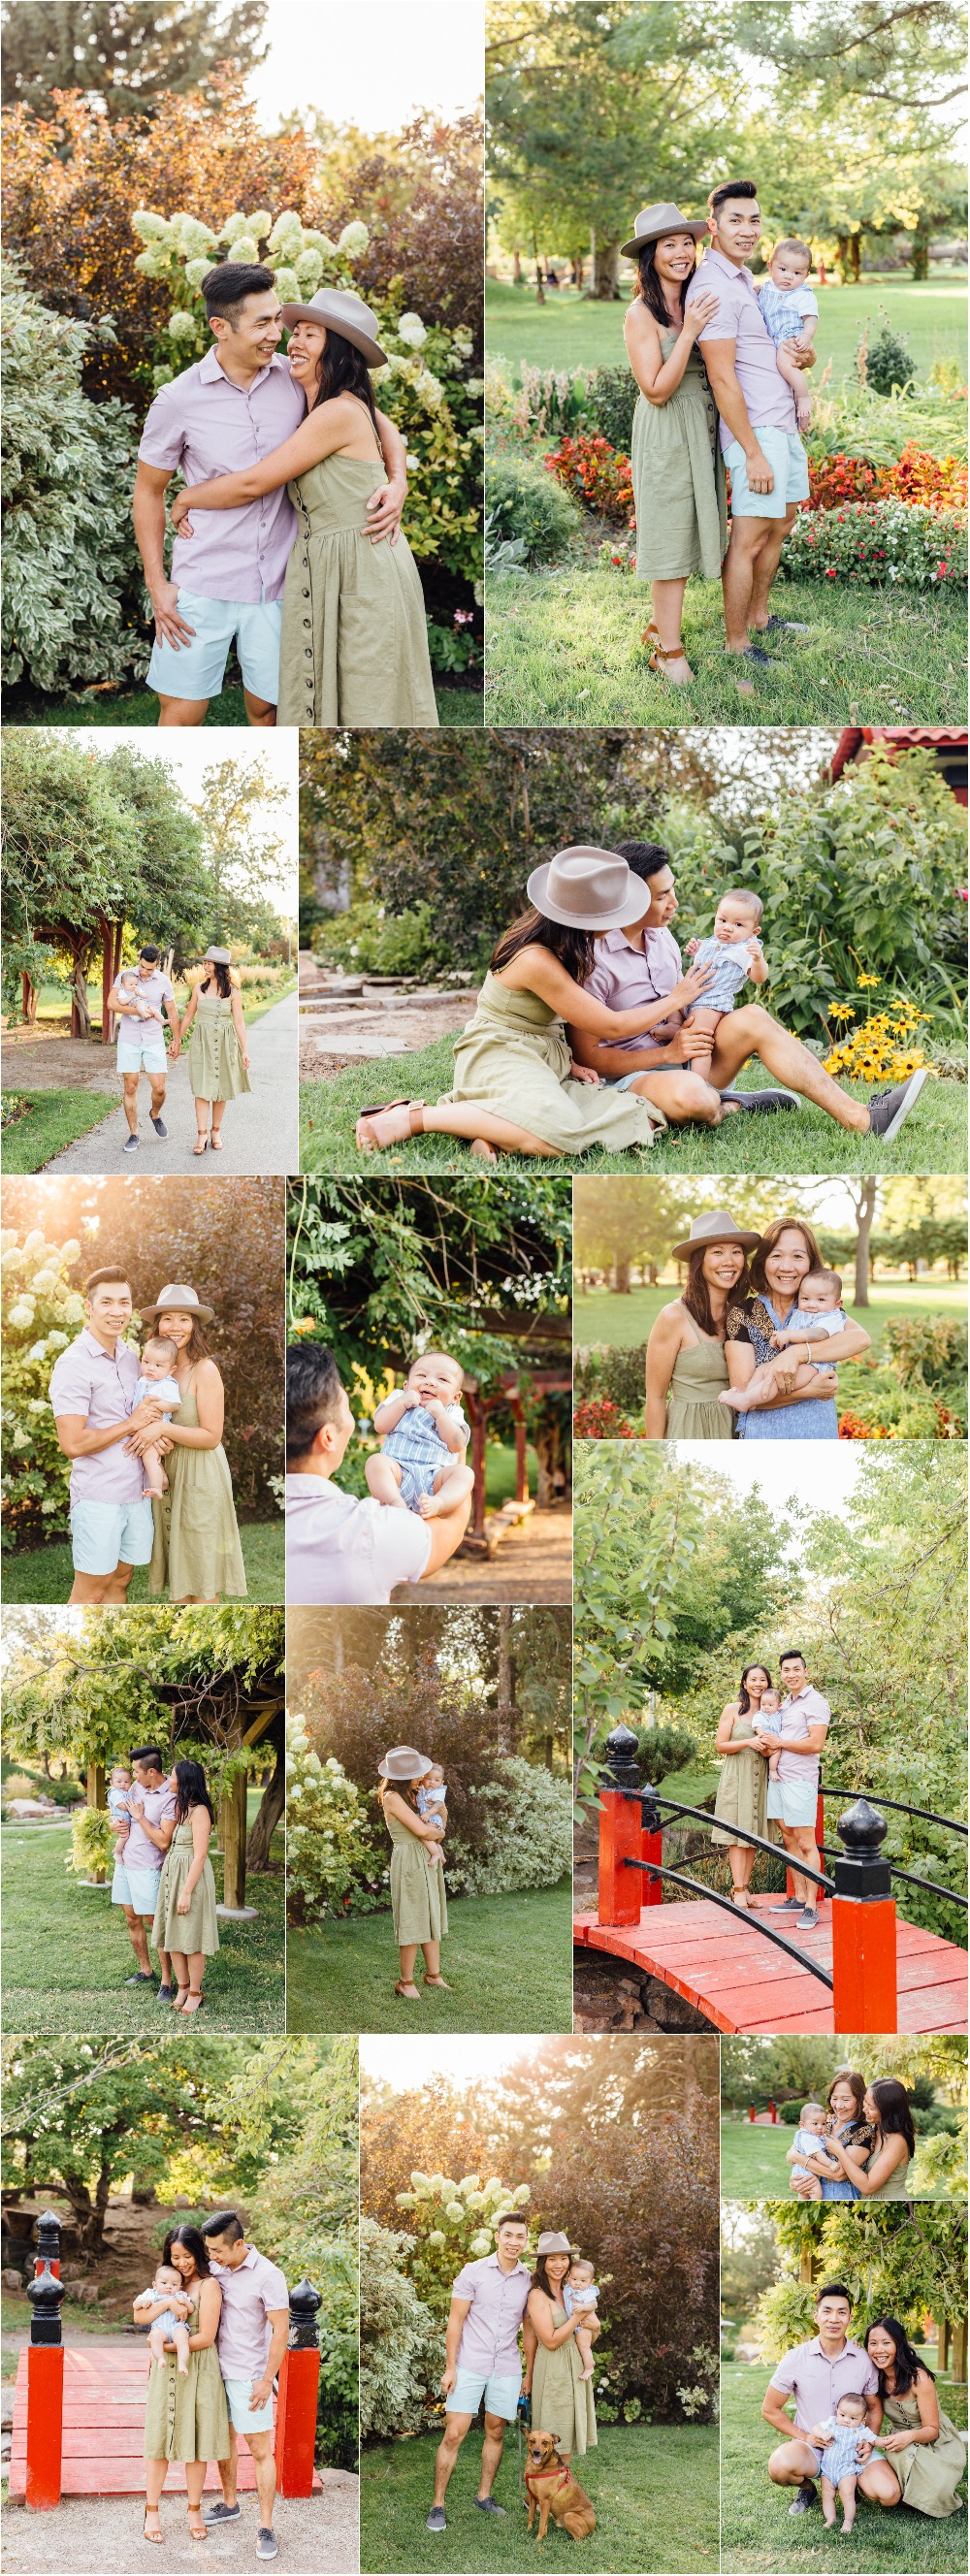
[3,1801,285,2033]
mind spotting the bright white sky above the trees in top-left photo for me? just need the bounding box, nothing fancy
[249,0,484,134]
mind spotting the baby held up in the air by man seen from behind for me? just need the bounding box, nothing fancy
[366,1350,473,1520]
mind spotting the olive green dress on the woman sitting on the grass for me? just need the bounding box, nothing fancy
[437,969,666,1154]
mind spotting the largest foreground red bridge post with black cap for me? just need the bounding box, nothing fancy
[831,1798,898,2033]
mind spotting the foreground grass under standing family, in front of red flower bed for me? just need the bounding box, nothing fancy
[486,559,967,726]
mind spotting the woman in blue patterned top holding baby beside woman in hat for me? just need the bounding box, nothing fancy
[723,1216,870,1440]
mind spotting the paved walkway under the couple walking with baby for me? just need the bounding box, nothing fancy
[41,992,299,1177]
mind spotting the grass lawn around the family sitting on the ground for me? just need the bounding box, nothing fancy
[301,1038,967,1177]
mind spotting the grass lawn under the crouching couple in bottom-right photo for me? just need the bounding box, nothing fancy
[721,2363,967,2576]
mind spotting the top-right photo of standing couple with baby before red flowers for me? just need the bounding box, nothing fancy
[486,0,967,726]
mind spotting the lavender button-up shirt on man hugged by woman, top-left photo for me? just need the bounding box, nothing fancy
[139,348,307,603]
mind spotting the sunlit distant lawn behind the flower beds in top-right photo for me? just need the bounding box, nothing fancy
[484,275,967,384]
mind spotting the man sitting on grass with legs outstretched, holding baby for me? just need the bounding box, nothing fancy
[568,840,926,1143]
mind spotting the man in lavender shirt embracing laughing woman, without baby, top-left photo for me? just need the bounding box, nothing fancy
[134,260,406,726]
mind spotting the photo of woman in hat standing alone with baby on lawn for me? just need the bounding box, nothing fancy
[285,1605,571,2043]
